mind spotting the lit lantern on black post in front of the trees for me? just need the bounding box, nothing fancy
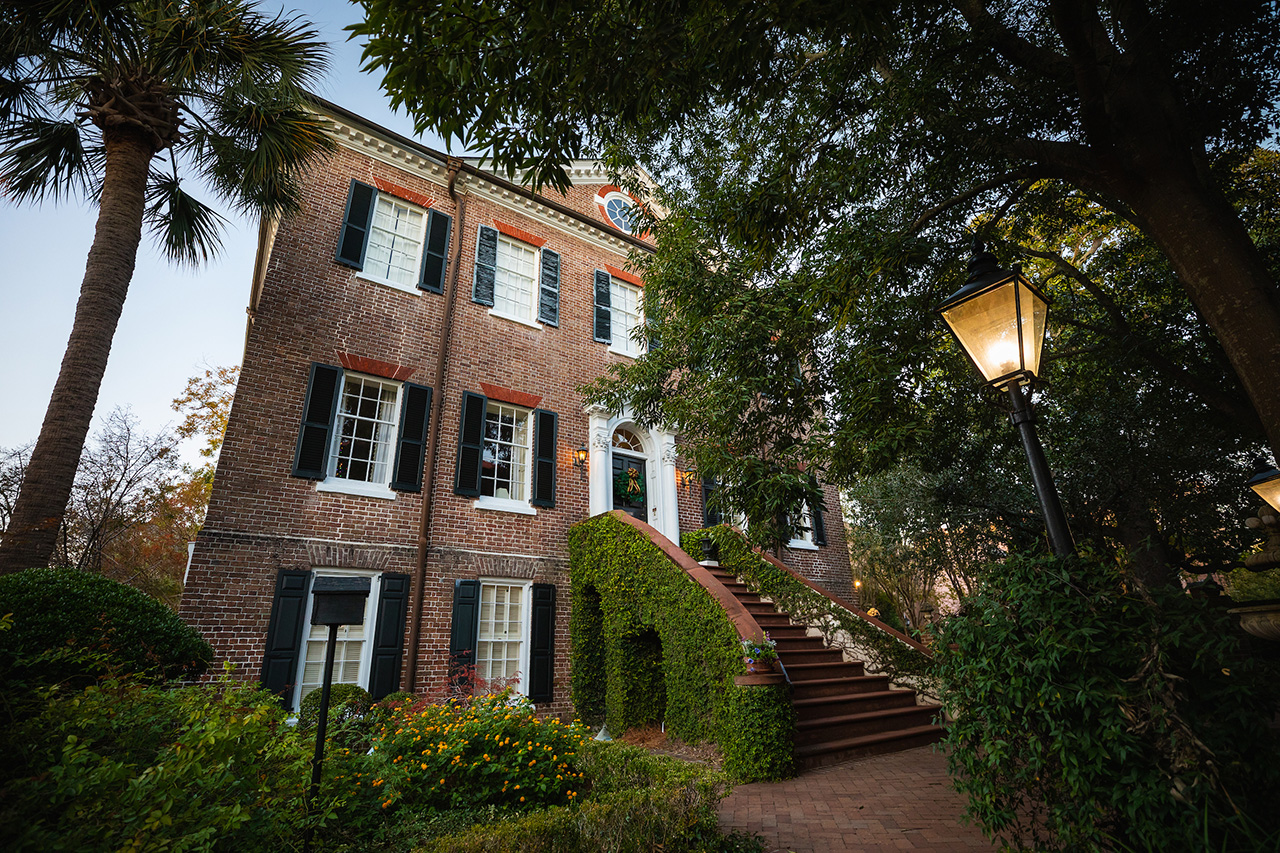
[938,240,1075,557]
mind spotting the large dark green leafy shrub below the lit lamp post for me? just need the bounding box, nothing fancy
[936,556,1280,850]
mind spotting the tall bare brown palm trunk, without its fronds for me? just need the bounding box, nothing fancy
[0,128,155,574]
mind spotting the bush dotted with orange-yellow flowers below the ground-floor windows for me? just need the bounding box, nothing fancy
[366,692,588,809]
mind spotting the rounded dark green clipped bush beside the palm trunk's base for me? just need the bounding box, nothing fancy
[0,569,214,685]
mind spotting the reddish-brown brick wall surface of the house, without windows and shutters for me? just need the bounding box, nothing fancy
[182,112,849,712]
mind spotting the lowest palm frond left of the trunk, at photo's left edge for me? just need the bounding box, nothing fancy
[0,117,95,201]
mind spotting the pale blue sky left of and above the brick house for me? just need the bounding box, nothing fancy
[0,0,444,464]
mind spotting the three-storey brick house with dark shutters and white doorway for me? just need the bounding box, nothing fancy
[182,100,852,712]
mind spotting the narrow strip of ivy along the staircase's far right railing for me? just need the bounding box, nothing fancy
[681,525,936,693]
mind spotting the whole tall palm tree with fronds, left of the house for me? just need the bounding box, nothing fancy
[0,0,333,573]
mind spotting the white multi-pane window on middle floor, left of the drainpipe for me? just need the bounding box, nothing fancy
[329,373,399,484]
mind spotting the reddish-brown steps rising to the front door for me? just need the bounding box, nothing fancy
[704,564,942,771]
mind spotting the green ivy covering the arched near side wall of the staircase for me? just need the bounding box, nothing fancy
[568,514,795,781]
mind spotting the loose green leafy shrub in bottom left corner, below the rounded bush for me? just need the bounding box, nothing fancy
[0,679,362,853]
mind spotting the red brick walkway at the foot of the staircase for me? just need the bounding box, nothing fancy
[719,747,998,853]
